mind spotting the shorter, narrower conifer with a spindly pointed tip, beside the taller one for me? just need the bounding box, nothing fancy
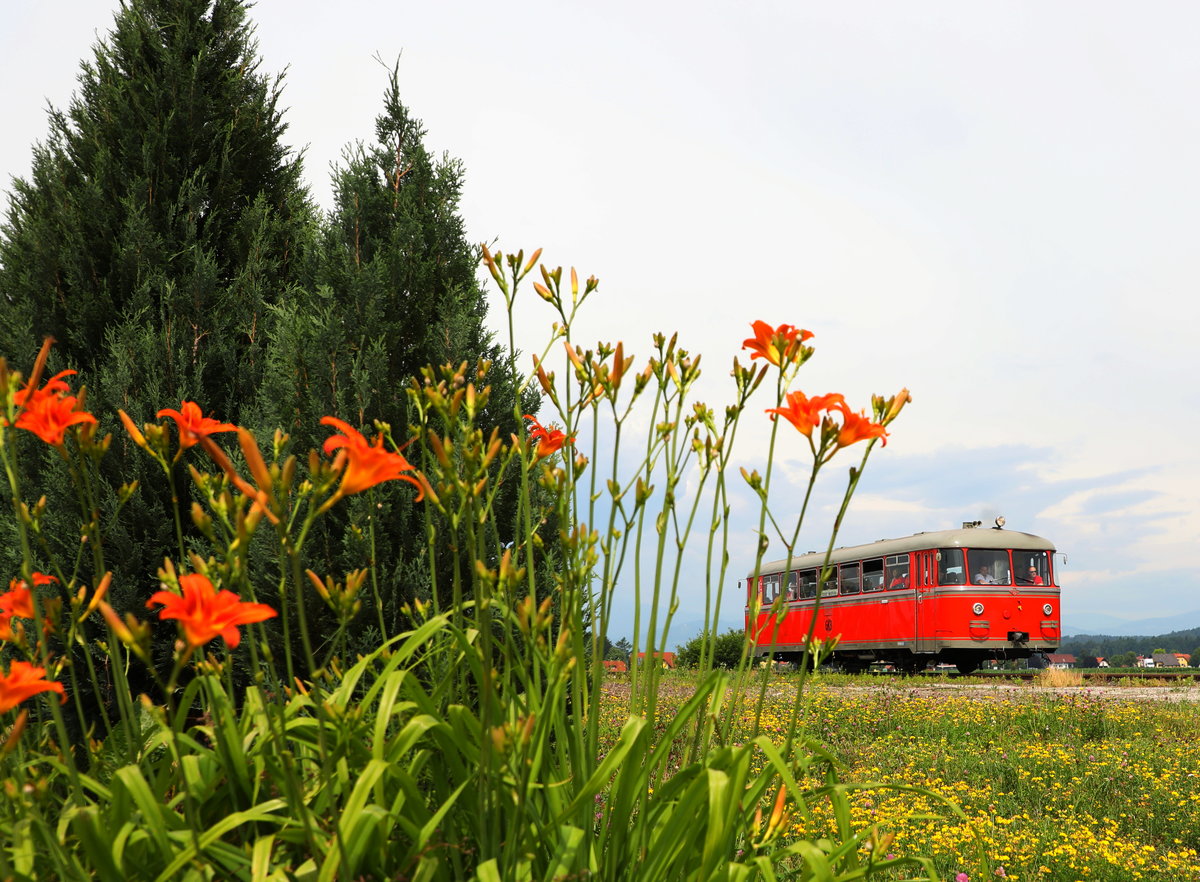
[263,68,536,623]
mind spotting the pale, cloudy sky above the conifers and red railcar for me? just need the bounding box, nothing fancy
[0,0,1200,638]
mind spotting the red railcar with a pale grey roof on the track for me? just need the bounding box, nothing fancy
[746,518,1060,673]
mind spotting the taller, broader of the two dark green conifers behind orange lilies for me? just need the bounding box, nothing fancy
[0,0,313,606]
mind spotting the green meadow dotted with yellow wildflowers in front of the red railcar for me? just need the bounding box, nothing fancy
[604,673,1200,882]
